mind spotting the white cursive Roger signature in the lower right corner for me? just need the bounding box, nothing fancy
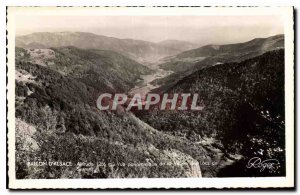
[246,157,280,173]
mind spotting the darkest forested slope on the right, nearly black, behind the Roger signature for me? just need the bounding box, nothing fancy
[138,50,285,177]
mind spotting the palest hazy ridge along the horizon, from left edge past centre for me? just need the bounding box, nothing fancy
[16,32,197,63]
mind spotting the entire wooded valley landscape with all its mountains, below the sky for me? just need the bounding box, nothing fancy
[15,32,285,179]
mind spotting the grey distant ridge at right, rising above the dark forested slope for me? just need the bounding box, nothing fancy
[161,35,284,71]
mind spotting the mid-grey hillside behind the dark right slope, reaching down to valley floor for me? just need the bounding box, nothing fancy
[153,35,284,88]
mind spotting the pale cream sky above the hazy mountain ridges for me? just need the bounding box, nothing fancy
[16,15,283,44]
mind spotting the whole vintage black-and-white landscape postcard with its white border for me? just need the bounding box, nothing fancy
[7,7,294,189]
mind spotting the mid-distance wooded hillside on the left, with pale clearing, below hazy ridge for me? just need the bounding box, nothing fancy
[16,46,152,92]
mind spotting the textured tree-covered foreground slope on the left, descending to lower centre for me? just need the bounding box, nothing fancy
[16,60,227,179]
